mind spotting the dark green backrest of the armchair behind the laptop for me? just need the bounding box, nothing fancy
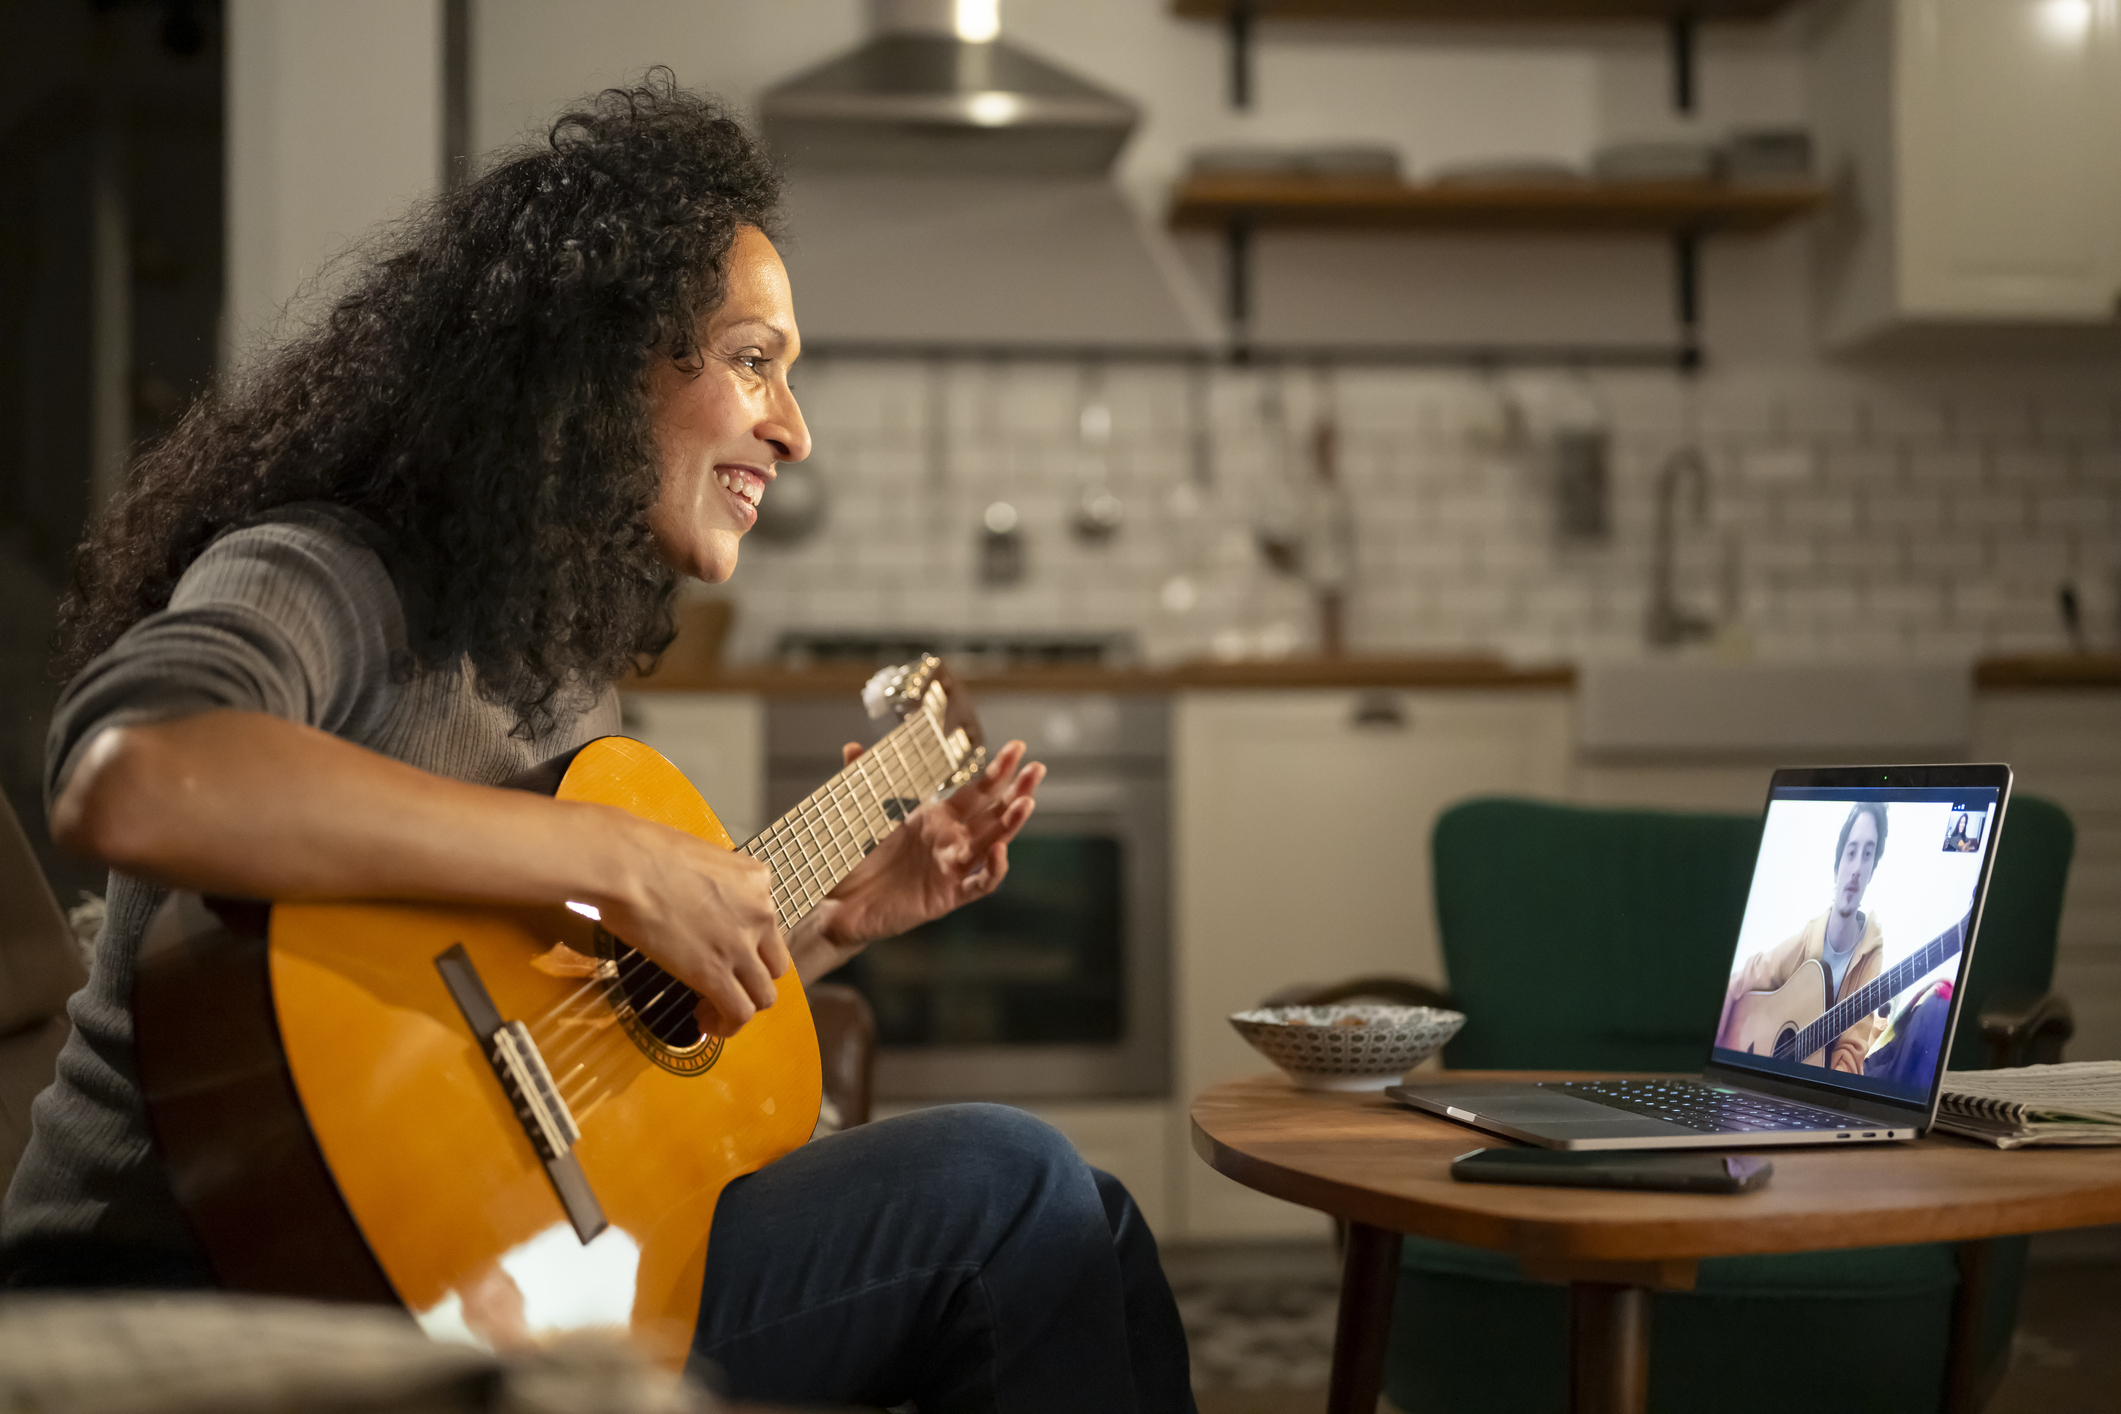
[1432,795,2074,1071]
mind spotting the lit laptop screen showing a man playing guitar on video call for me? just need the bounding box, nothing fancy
[1714,780,2002,1107]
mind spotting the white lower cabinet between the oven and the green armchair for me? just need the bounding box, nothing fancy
[1173,691,1570,1240]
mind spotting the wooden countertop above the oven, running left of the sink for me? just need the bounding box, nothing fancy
[619,655,1576,697]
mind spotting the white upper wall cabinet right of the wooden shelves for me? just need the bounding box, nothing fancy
[1811,0,2121,343]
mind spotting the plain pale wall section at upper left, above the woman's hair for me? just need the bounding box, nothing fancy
[221,0,441,367]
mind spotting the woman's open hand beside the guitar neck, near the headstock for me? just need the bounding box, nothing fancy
[789,742,1046,984]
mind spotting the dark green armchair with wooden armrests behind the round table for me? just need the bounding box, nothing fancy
[1275,797,2074,1414]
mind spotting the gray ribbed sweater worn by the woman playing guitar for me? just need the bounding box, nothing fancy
[0,505,619,1255]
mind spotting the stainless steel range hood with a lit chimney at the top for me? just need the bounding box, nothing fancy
[759,0,1141,178]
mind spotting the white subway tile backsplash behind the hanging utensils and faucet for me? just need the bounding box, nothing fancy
[719,360,2121,661]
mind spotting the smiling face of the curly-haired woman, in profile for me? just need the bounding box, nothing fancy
[649,227,810,583]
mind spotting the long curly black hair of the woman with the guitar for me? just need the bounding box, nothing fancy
[55,70,781,733]
